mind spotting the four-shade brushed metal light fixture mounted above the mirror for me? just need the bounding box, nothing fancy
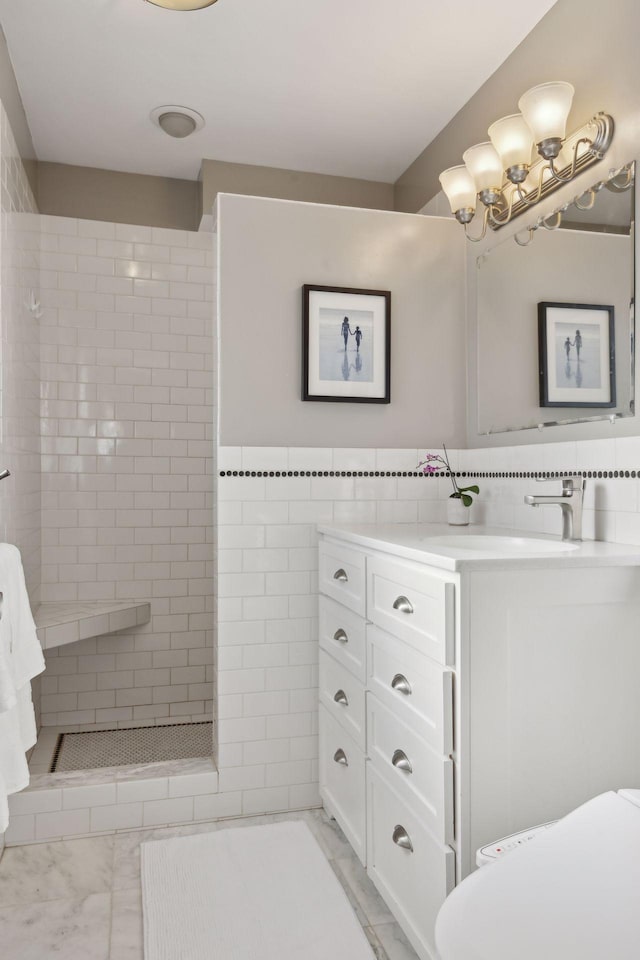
[440,80,617,242]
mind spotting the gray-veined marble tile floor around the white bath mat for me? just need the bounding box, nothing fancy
[0,809,417,960]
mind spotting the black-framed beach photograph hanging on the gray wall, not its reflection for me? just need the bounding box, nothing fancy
[302,284,391,403]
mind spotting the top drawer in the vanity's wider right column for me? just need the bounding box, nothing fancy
[367,557,455,665]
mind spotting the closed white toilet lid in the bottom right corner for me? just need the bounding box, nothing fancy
[435,790,640,960]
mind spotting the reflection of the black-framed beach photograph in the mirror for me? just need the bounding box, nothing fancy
[538,301,616,407]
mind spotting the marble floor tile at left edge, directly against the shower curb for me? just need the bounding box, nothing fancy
[0,837,114,907]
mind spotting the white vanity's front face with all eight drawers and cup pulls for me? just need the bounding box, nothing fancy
[319,538,455,958]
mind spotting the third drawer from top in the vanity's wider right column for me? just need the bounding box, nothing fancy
[367,693,453,843]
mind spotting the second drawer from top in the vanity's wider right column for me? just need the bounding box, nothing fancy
[367,624,453,754]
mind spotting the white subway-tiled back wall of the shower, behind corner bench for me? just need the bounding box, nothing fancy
[40,216,214,726]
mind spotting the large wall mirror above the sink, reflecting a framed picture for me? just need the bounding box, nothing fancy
[476,164,635,435]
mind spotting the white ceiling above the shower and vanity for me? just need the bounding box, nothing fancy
[0,0,554,182]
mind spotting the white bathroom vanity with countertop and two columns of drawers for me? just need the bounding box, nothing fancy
[319,524,640,960]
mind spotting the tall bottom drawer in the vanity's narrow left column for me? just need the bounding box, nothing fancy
[319,704,366,864]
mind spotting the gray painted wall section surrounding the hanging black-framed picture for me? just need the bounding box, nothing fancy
[218,195,465,447]
